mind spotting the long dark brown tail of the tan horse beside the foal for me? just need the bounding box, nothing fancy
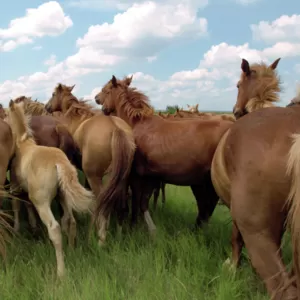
[95,126,135,220]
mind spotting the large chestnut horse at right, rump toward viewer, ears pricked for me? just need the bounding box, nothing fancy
[212,59,300,299]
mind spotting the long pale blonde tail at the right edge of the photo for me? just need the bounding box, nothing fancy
[287,134,300,299]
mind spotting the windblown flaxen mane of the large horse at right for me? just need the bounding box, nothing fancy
[241,63,281,112]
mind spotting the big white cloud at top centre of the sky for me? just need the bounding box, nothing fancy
[77,1,207,57]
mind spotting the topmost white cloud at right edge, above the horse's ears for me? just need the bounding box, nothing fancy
[250,15,300,43]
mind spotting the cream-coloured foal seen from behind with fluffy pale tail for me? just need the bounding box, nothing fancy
[8,100,94,277]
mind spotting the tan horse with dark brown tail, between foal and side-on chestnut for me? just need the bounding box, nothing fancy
[45,84,135,245]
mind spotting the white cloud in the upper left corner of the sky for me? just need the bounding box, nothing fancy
[0,1,73,52]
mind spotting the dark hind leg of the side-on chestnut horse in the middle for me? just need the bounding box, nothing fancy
[191,172,219,227]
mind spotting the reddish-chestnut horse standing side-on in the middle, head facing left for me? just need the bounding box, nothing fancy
[95,76,232,233]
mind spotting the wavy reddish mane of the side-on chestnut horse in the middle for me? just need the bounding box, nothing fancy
[117,87,154,123]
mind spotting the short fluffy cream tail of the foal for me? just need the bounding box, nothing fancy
[56,158,95,212]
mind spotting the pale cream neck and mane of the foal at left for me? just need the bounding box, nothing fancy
[8,100,35,146]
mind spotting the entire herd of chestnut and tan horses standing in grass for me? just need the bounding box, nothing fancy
[0,59,300,299]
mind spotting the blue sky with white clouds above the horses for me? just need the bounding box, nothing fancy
[0,0,300,111]
